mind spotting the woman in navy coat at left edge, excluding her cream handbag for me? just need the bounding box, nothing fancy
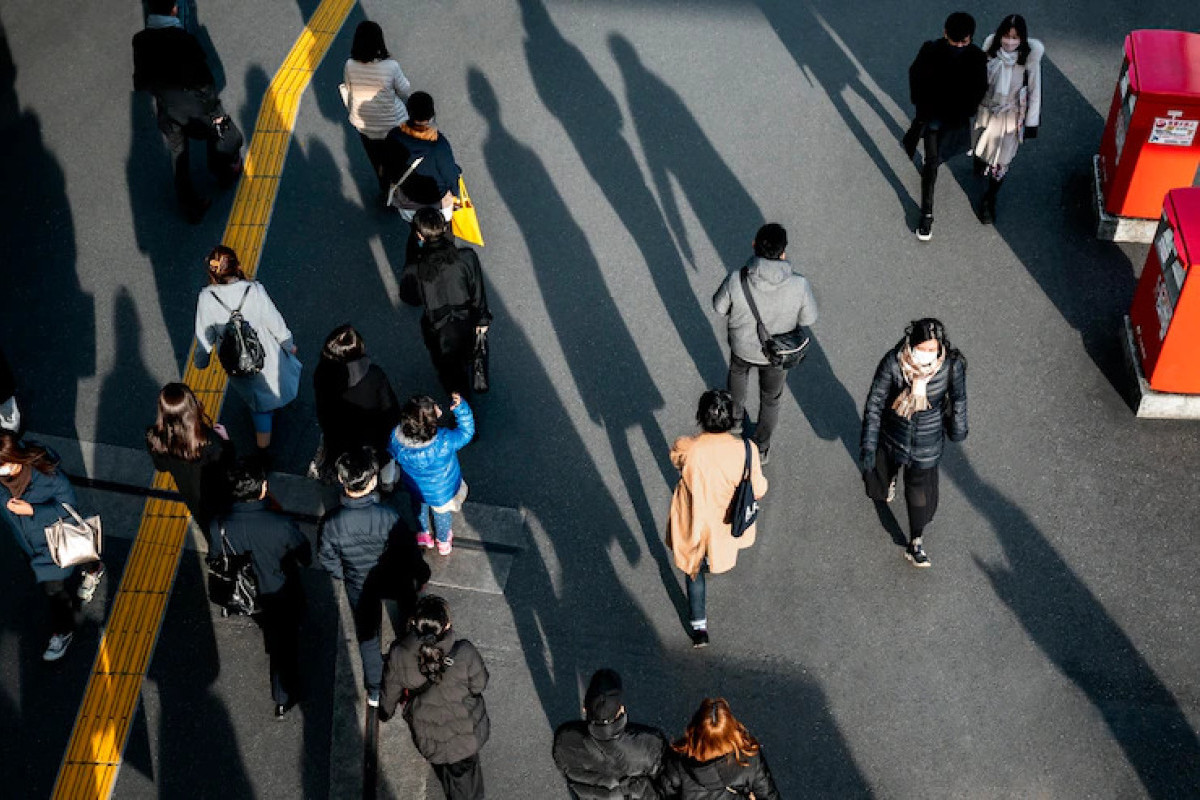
[0,431,104,661]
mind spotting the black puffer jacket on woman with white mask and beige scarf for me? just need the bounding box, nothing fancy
[860,342,967,469]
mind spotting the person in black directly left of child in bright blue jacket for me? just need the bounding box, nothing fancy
[312,325,400,489]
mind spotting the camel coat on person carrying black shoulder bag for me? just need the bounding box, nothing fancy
[667,433,767,578]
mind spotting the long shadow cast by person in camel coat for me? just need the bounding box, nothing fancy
[467,67,685,633]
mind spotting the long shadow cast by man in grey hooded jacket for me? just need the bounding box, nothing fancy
[520,0,724,377]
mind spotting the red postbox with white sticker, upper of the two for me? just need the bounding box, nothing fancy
[1100,30,1200,219]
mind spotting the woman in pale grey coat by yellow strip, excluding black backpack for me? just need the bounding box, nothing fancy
[194,245,301,459]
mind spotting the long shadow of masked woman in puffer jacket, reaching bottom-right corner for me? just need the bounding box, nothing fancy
[942,447,1200,798]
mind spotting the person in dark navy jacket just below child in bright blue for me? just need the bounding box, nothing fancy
[317,447,430,706]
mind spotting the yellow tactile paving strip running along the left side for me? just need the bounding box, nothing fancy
[53,0,355,800]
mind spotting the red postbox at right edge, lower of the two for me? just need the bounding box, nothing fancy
[1129,188,1200,395]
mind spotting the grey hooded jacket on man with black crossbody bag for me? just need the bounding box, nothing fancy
[713,255,817,365]
